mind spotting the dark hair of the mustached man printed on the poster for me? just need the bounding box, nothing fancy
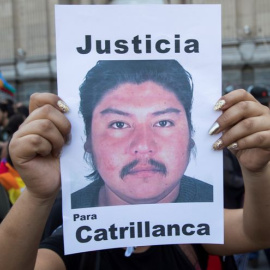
[80,60,193,180]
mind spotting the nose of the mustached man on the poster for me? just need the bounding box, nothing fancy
[130,125,157,155]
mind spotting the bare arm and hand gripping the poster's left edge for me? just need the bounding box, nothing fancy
[0,94,70,270]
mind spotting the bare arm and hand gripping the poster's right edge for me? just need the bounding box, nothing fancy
[204,90,270,255]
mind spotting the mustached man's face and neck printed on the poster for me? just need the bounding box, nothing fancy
[85,81,190,205]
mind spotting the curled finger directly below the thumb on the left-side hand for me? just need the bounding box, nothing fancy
[20,104,71,138]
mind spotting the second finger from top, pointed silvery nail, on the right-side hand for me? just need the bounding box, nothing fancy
[209,101,269,135]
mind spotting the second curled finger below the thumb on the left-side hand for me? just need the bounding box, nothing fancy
[15,119,65,155]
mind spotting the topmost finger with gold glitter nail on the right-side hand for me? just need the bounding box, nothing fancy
[214,89,259,111]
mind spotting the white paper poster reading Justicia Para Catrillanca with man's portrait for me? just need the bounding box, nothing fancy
[56,5,223,254]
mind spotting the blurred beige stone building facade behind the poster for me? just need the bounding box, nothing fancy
[0,0,270,102]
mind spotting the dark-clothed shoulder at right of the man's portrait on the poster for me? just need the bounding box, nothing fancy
[176,175,213,202]
